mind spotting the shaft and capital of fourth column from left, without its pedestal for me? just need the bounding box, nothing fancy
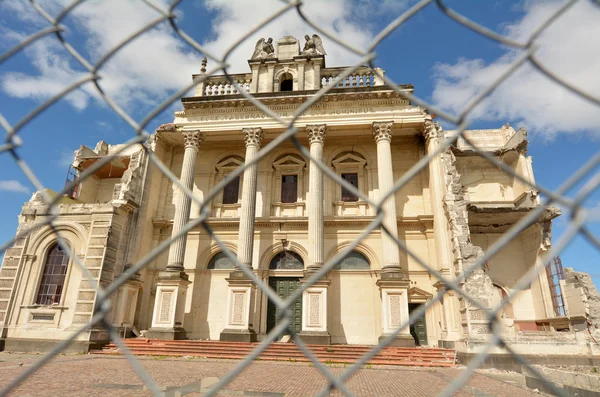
[373,121,401,273]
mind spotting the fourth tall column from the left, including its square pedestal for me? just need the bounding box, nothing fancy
[373,121,415,346]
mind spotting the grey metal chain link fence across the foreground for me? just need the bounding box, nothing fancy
[0,0,600,396]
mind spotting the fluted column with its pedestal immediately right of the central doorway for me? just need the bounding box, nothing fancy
[300,124,331,345]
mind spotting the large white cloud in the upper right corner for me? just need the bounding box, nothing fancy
[432,0,600,138]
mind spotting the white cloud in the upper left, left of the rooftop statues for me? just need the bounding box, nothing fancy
[1,0,200,109]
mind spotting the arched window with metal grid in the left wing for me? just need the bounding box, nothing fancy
[35,244,69,305]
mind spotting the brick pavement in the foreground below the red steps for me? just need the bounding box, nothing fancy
[0,353,538,397]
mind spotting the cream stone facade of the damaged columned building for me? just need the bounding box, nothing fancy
[0,37,589,354]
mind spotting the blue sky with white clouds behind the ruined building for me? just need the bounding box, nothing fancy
[0,0,600,284]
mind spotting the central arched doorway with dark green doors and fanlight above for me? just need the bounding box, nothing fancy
[267,251,304,333]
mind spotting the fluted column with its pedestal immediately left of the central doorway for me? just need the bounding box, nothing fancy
[220,128,263,342]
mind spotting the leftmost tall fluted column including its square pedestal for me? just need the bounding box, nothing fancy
[148,130,204,339]
